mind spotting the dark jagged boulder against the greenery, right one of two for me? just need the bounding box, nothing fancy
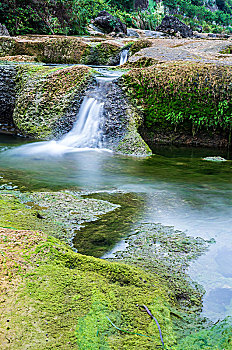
[156,16,193,38]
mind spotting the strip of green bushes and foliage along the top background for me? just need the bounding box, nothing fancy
[0,0,232,35]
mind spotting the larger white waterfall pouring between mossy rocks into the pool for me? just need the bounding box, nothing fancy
[7,68,123,155]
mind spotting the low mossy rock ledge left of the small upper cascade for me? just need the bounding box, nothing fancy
[0,36,129,65]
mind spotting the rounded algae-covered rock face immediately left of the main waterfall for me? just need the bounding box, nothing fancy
[13,65,91,139]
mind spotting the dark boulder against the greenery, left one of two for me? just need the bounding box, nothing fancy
[93,11,127,34]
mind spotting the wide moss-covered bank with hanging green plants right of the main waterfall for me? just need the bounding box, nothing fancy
[123,62,232,146]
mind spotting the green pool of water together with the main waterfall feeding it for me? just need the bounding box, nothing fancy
[0,65,232,320]
